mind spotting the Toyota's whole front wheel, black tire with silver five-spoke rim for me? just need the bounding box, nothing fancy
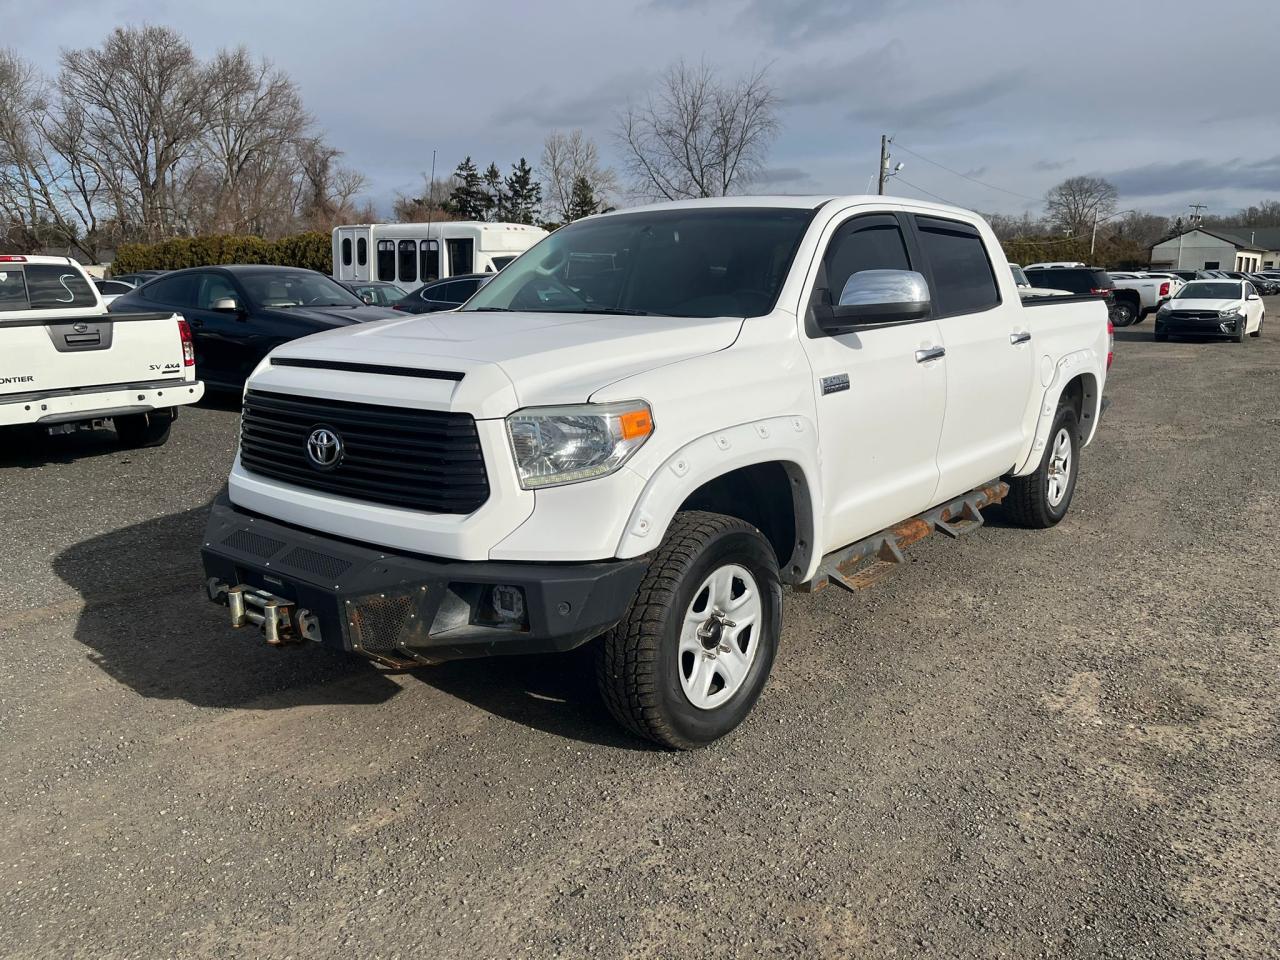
[596,511,782,750]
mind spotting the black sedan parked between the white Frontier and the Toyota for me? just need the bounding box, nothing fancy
[110,265,397,389]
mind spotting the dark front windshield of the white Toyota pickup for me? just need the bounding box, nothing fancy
[462,207,813,317]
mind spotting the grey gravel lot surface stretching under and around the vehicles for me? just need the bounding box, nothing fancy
[0,309,1280,959]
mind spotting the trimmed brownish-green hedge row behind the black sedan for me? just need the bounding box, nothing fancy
[111,232,333,275]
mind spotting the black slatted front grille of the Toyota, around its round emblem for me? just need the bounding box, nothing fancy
[241,390,489,513]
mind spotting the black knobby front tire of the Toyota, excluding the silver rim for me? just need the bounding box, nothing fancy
[596,511,782,750]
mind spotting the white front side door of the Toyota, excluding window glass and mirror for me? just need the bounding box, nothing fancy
[800,214,947,553]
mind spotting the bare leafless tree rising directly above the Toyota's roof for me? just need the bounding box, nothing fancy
[611,61,778,200]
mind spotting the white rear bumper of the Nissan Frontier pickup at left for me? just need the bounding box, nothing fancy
[0,380,205,426]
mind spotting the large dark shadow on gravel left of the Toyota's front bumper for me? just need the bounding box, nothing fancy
[52,504,399,709]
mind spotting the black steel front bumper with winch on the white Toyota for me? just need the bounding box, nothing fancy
[201,495,648,666]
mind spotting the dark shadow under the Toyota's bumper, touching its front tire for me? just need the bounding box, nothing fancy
[411,646,658,751]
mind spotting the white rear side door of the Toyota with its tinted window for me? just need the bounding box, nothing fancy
[911,214,1036,503]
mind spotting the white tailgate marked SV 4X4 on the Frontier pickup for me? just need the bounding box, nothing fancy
[0,314,183,398]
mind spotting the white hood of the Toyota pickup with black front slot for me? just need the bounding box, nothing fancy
[264,311,744,419]
